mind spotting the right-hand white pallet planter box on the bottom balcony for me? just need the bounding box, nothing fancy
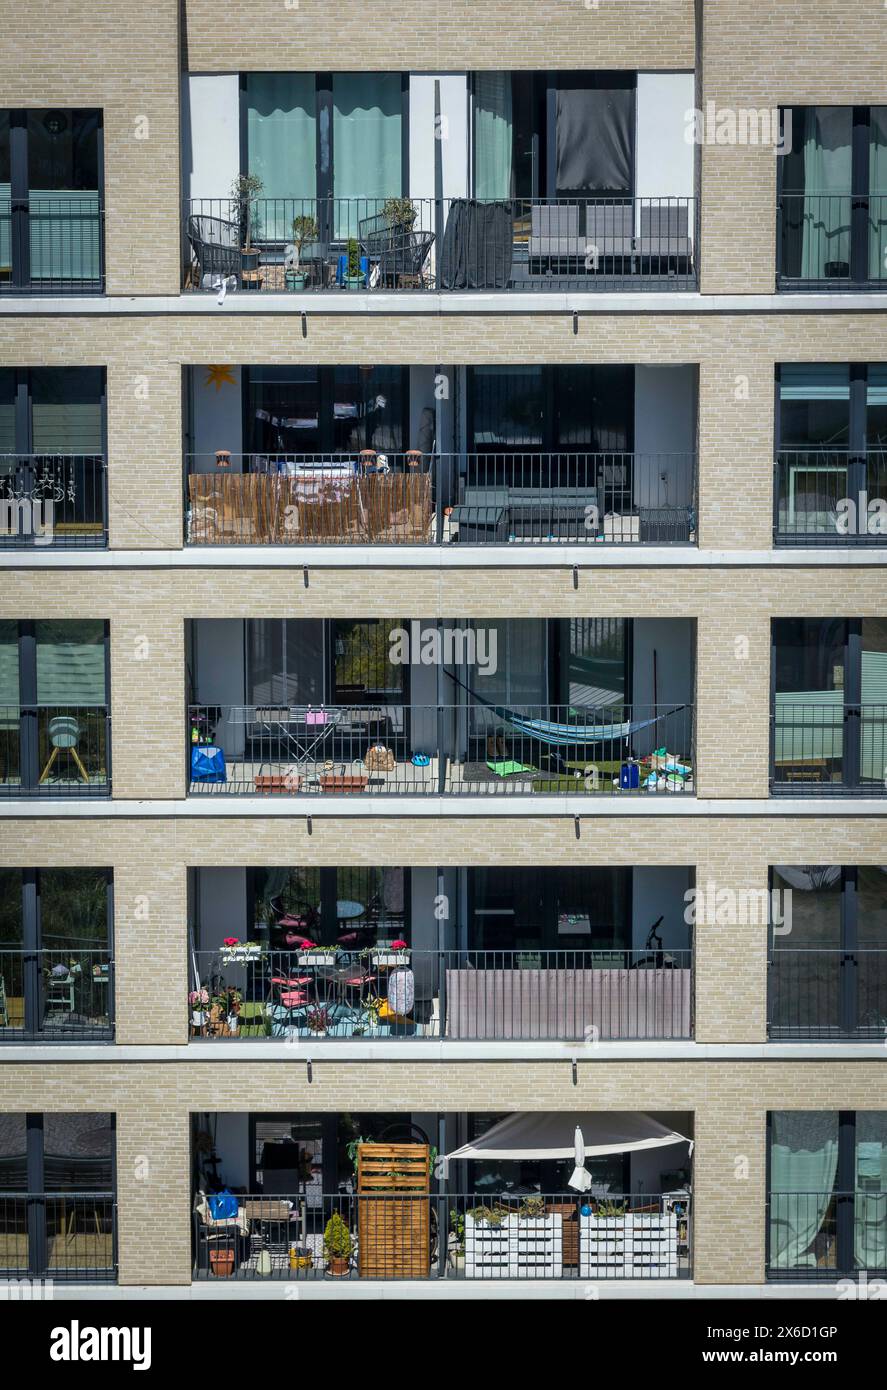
[578,1212,677,1279]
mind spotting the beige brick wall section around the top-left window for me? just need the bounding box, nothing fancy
[0,0,182,295]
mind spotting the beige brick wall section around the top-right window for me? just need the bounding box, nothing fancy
[701,0,887,295]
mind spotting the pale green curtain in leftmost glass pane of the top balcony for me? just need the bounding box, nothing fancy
[246,72,317,242]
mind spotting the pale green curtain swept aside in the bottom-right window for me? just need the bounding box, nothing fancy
[770,1111,838,1269]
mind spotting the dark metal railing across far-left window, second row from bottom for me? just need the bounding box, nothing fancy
[0,947,114,1043]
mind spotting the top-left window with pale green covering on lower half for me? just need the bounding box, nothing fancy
[0,110,103,293]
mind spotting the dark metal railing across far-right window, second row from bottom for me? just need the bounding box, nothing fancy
[769,947,887,1043]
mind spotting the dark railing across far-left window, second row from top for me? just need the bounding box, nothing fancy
[0,453,108,549]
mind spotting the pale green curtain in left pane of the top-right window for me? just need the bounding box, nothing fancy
[792,106,852,279]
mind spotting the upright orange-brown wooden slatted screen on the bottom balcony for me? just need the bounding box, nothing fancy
[357,1144,431,1279]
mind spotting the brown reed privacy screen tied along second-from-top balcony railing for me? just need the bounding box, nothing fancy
[188,473,432,545]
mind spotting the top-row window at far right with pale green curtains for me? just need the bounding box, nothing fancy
[779,106,887,285]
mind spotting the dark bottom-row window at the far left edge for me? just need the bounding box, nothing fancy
[0,1112,117,1283]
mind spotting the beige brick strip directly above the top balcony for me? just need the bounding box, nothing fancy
[185,0,694,72]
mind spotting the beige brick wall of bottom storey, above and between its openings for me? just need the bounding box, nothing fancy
[0,1058,881,1284]
